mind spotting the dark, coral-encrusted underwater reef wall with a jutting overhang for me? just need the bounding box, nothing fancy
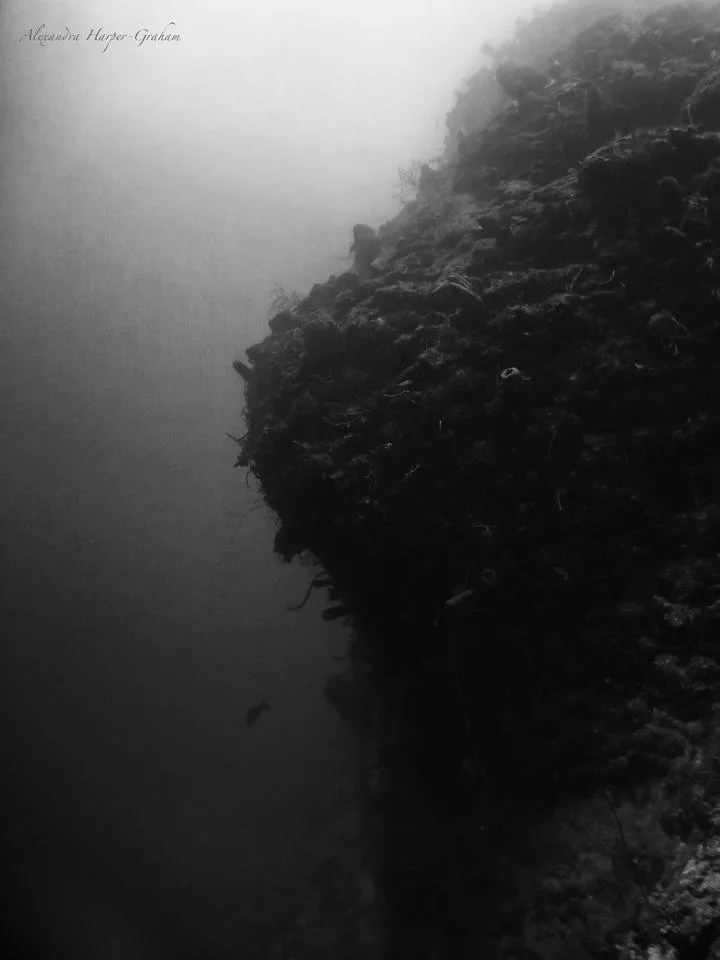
[236,3,720,960]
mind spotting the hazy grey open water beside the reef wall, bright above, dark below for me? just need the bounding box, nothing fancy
[0,0,528,944]
